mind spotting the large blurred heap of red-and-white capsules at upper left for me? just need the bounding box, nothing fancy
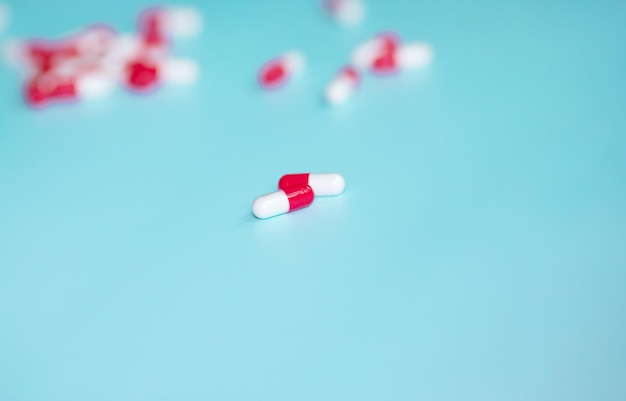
[4,7,202,107]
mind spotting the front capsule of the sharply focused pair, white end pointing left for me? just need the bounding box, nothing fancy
[252,184,315,219]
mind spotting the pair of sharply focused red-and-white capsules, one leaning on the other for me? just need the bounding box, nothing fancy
[252,173,346,219]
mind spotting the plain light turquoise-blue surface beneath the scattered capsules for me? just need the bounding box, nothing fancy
[0,0,626,401]
